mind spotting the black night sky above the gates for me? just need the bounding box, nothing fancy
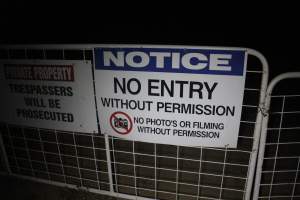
[0,1,300,78]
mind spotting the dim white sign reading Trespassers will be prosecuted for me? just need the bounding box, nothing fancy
[0,60,98,133]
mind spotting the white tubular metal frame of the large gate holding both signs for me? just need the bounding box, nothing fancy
[0,44,269,200]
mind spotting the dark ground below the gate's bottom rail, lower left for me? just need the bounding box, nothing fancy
[0,175,124,200]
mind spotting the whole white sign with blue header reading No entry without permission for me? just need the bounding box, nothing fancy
[94,46,247,147]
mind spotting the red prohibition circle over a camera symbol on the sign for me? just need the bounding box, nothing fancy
[109,112,132,135]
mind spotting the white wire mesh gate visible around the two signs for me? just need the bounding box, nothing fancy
[0,45,268,200]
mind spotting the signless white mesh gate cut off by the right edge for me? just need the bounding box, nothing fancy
[253,72,300,200]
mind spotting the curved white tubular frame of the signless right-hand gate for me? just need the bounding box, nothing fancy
[253,72,300,200]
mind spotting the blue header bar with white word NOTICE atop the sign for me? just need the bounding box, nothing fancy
[95,48,245,76]
